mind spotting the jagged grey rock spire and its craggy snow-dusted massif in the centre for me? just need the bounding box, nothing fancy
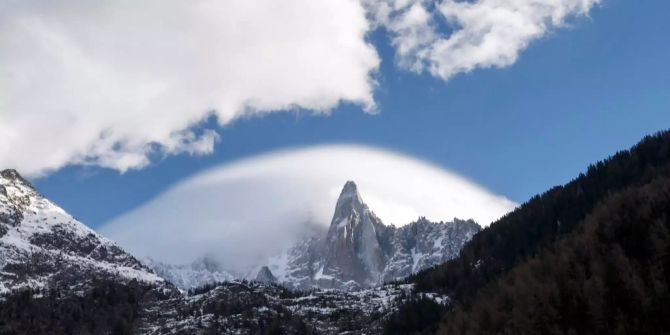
[268,181,481,289]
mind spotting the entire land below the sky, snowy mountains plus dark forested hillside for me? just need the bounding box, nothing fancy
[0,131,670,334]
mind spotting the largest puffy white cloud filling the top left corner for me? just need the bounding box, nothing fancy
[0,0,379,175]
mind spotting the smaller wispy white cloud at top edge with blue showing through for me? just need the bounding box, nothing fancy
[364,0,600,80]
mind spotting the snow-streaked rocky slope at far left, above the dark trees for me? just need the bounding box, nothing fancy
[0,170,164,293]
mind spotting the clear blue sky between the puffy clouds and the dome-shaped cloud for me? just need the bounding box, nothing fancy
[14,0,670,227]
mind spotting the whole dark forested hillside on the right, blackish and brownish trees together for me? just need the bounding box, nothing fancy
[387,131,670,334]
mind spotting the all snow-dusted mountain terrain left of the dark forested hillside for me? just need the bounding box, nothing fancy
[0,170,472,334]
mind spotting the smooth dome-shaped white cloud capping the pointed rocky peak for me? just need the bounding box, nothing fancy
[101,145,516,270]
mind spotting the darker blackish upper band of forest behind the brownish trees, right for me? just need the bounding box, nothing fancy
[412,131,670,301]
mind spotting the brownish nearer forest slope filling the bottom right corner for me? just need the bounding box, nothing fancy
[440,178,670,334]
